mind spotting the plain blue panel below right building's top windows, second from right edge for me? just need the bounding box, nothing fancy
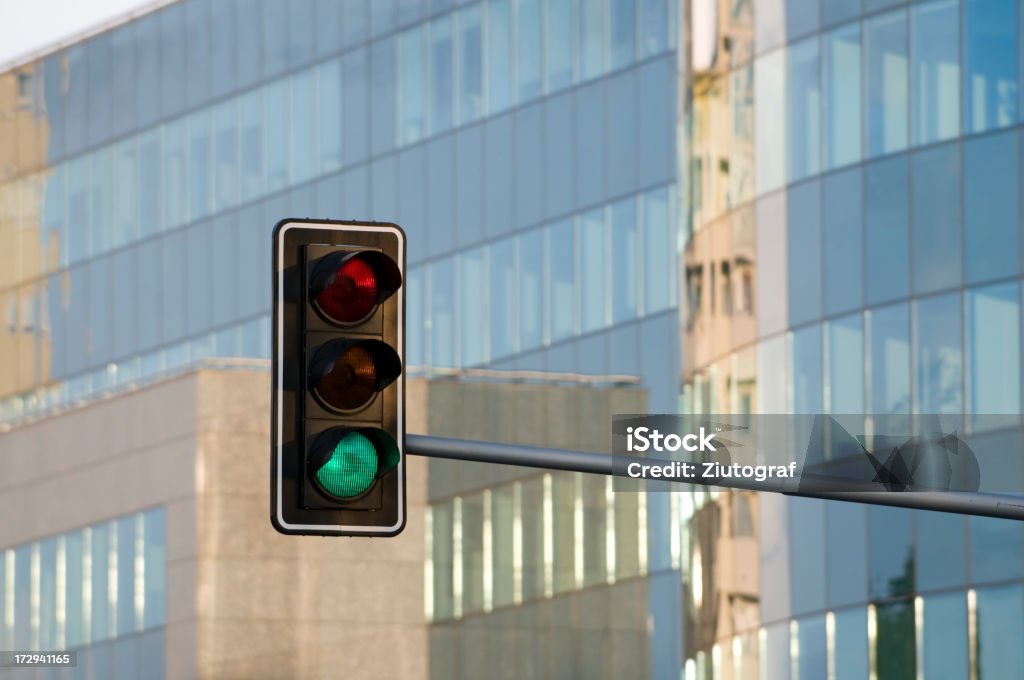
[911,144,961,293]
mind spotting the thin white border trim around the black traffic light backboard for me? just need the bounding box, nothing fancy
[274,221,406,534]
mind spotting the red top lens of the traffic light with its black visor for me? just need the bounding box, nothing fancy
[310,251,401,326]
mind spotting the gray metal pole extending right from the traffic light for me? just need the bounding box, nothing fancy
[406,434,1024,519]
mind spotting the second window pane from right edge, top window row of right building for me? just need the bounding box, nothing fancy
[910,0,959,144]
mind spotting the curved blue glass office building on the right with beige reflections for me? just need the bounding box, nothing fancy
[681,0,1024,680]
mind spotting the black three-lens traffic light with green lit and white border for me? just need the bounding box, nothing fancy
[270,219,406,536]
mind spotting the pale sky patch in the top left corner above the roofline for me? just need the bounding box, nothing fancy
[0,0,155,67]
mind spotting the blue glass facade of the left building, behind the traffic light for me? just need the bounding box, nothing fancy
[0,0,676,426]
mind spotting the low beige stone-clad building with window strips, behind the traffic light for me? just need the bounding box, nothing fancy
[0,360,649,680]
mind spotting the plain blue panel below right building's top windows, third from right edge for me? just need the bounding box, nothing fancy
[864,156,910,304]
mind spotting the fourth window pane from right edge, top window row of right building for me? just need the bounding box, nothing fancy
[821,24,861,168]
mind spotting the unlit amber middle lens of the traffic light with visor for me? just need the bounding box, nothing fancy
[309,340,401,413]
